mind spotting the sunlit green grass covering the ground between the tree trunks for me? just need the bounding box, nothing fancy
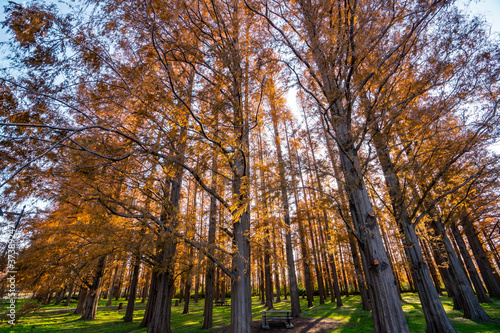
[0,294,500,333]
